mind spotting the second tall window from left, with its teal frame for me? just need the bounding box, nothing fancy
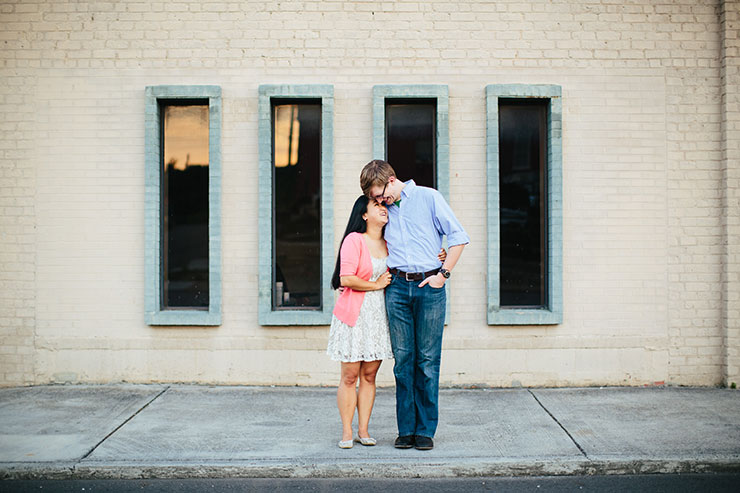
[259,85,334,325]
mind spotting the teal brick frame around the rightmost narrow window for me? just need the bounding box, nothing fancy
[486,84,563,325]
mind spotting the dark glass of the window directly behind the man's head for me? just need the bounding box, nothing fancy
[385,98,437,188]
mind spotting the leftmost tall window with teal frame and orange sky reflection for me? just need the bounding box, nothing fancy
[146,86,221,325]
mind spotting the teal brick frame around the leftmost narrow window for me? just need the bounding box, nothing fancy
[144,85,221,326]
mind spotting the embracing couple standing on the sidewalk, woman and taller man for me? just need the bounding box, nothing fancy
[327,160,470,450]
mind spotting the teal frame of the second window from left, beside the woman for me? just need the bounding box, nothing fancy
[258,84,334,325]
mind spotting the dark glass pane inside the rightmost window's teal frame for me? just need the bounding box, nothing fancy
[499,99,549,307]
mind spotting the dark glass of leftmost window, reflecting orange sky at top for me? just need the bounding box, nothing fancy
[160,101,209,309]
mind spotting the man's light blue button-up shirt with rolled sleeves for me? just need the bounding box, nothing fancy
[385,180,470,272]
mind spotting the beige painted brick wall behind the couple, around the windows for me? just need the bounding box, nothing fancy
[0,0,739,386]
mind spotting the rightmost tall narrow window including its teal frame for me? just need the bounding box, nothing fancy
[486,85,562,325]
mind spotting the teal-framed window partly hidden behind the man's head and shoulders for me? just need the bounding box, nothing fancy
[373,85,450,200]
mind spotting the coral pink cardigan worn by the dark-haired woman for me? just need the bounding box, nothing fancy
[333,233,384,327]
